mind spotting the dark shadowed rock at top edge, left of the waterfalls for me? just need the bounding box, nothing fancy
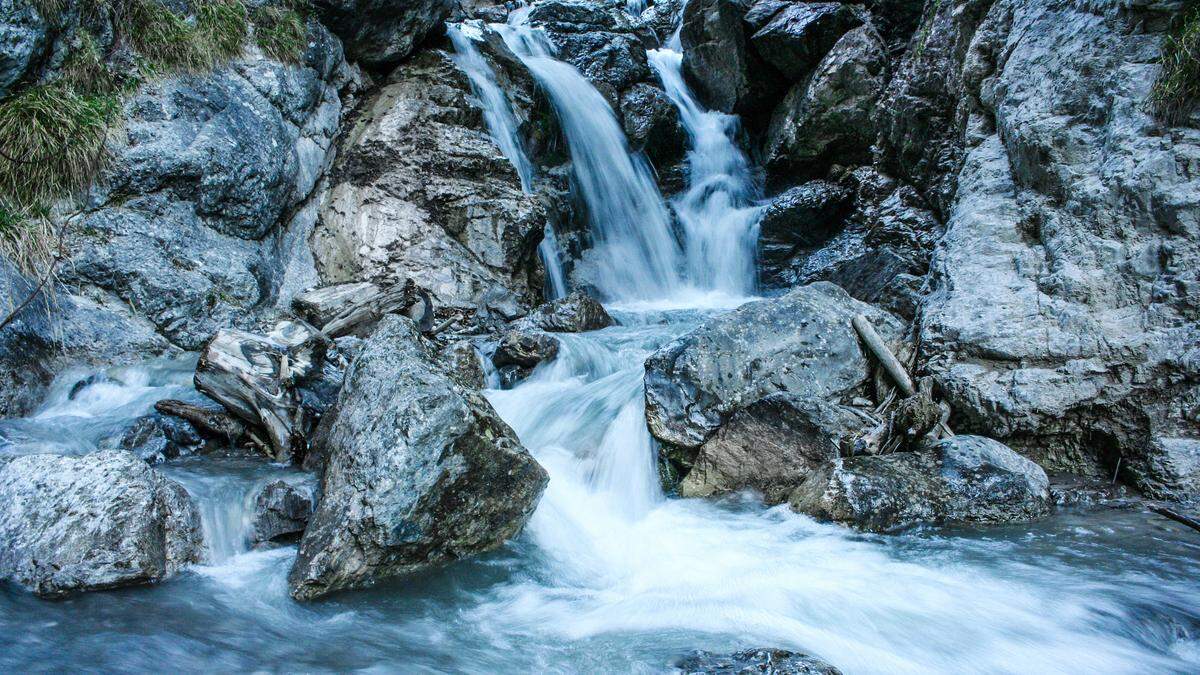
[313,0,455,66]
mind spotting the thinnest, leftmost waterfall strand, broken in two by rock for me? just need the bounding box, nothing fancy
[446,22,566,300]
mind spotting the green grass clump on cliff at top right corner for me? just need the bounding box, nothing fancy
[1150,0,1200,125]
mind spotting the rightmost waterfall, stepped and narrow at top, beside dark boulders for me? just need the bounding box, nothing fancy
[647,49,761,295]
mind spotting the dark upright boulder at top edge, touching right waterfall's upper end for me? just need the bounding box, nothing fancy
[679,0,786,117]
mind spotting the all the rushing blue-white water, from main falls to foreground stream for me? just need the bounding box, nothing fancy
[0,10,1200,673]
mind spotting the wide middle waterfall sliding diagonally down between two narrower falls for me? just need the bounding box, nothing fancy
[493,21,683,300]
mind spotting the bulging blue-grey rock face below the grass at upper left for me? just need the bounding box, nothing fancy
[61,24,349,350]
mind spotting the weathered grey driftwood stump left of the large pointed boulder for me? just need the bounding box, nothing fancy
[194,330,324,462]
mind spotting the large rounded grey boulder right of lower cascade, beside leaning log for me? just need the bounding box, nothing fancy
[646,283,901,448]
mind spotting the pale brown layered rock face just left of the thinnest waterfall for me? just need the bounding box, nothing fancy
[311,49,547,309]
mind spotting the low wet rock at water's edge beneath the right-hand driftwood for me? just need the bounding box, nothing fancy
[790,436,1052,532]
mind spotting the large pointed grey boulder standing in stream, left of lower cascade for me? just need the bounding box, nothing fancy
[288,317,547,599]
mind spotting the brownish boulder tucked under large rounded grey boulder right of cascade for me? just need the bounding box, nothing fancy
[679,393,870,503]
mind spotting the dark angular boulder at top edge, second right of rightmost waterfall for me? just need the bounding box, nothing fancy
[749,0,863,82]
